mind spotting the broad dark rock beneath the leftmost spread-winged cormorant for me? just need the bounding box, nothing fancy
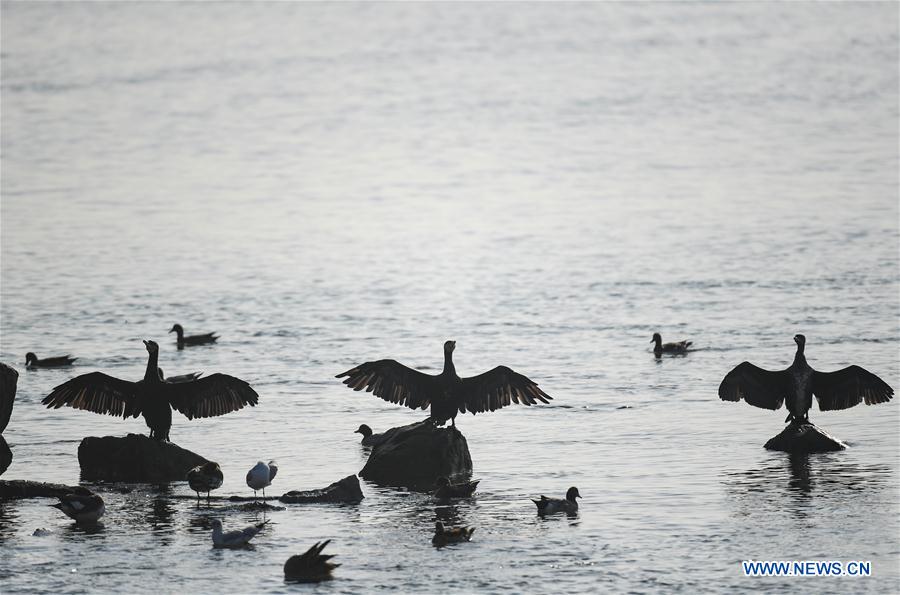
[78,434,209,483]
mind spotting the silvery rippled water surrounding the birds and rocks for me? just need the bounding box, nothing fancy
[0,2,900,593]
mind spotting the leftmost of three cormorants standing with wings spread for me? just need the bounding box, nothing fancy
[41,341,259,441]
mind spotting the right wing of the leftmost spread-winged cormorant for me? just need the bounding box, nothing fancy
[166,374,259,419]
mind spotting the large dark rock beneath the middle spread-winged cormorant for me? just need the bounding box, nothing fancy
[359,420,472,491]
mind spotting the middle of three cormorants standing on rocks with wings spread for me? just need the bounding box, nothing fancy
[335,341,552,427]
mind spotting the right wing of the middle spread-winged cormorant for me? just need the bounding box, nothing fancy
[459,366,553,413]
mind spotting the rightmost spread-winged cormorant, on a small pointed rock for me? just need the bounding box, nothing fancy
[719,335,894,423]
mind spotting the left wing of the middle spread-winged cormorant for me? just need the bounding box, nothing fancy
[335,359,441,409]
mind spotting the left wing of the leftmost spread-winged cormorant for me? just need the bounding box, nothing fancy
[41,372,141,417]
